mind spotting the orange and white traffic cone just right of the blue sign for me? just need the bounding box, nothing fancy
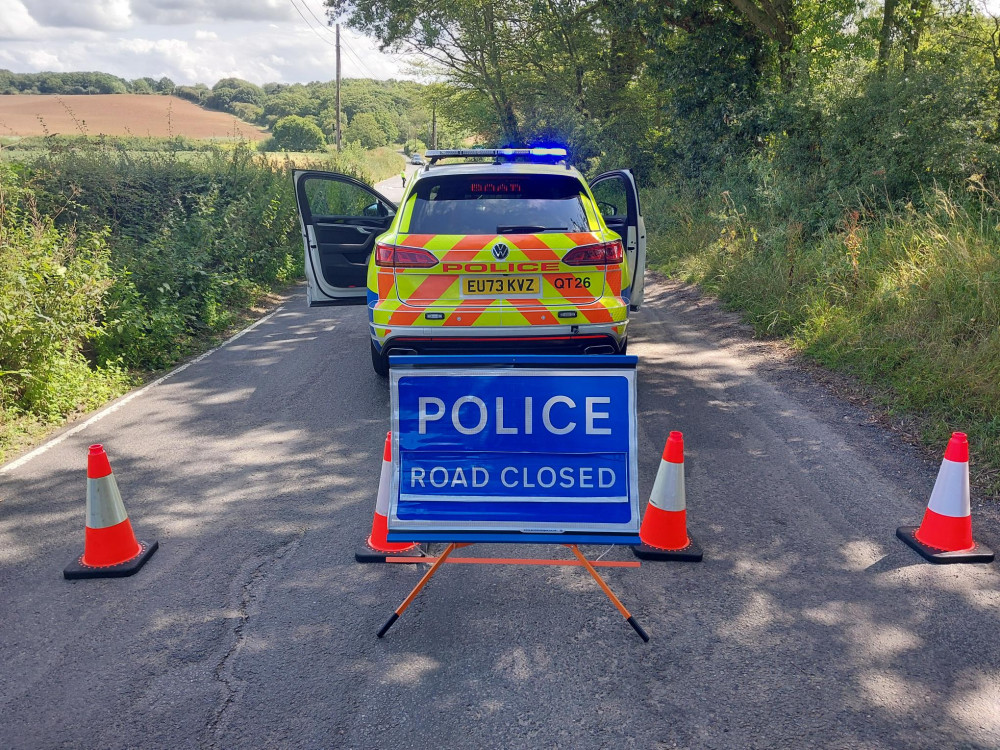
[632,431,702,562]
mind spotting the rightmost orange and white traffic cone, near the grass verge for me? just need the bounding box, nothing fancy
[896,432,993,563]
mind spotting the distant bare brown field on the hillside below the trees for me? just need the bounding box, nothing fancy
[0,94,267,141]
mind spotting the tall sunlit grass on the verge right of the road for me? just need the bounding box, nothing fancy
[644,177,1000,494]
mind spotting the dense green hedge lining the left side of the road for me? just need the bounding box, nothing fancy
[0,138,302,458]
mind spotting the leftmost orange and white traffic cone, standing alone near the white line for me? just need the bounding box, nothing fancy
[63,445,159,579]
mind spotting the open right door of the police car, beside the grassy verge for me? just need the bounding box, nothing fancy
[590,169,646,310]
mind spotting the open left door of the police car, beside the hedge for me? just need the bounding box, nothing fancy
[292,169,396,307]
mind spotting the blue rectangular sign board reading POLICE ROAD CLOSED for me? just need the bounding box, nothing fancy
[389,356,640,544]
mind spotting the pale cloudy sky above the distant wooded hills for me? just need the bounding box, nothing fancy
[0,0,412,86]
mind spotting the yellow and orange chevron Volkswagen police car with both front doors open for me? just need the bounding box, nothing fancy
[294,148,646,376]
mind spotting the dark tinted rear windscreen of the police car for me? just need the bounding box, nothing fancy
[406,174,590,234]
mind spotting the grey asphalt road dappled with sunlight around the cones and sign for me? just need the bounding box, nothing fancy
[0,281,1000,748]
